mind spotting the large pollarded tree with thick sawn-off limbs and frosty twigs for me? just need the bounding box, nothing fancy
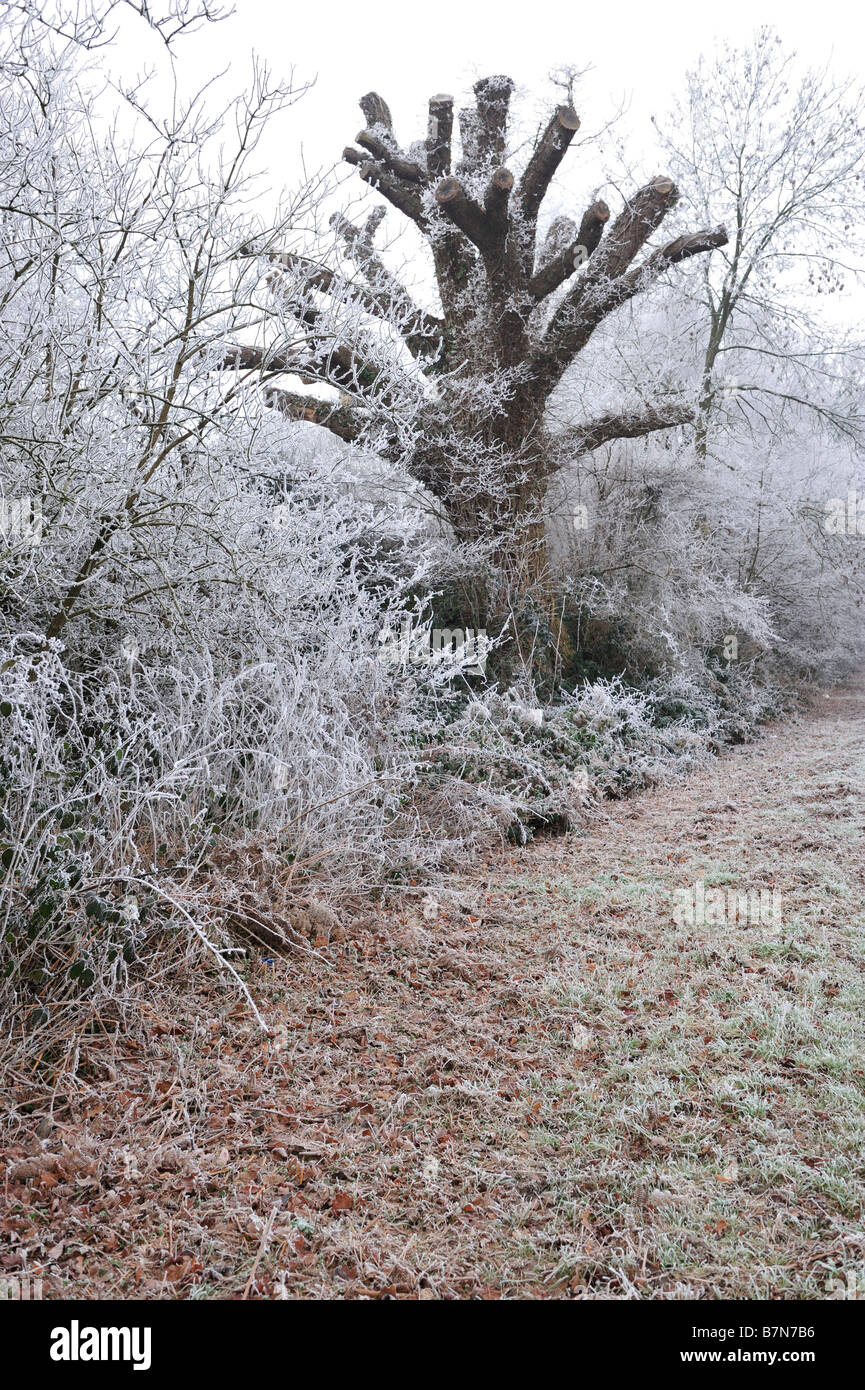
[234,76,727,617]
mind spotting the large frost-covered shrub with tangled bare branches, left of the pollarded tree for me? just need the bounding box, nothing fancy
[0,21,459,1037]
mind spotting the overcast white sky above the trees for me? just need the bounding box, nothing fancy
[116,0,865,198]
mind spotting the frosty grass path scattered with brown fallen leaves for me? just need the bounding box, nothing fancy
[0,685,865,1298]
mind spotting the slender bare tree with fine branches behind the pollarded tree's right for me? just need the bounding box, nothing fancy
[658,29,865,459]
